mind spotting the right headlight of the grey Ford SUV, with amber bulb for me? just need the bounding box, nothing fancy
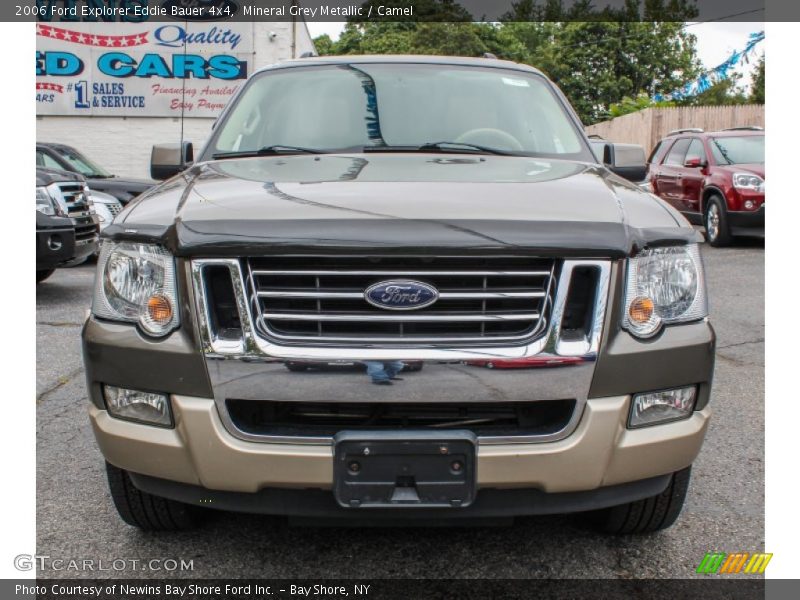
[622,244,708,337]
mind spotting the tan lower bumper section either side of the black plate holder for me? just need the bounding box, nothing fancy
[90,396,709,494]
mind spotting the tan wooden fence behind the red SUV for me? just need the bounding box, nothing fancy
[586,104,764,154]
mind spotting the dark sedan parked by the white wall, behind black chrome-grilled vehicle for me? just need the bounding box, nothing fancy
[36,142,156,206]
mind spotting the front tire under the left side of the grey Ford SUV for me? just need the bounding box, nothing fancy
[106,463,203,531]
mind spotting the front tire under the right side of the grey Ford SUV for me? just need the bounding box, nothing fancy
[591,467,692,535]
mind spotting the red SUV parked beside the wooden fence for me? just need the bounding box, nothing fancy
[648,127,764,246]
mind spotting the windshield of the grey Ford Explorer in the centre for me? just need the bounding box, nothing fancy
[206,64,591,160]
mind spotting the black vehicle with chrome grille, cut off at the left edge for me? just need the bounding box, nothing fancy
[36,168,98,283]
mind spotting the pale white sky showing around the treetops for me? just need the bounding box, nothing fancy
[308,21,766,85]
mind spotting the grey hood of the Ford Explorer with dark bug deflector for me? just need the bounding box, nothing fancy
[106,153,696,256]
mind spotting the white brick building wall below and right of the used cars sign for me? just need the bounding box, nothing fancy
[36,21,314,178]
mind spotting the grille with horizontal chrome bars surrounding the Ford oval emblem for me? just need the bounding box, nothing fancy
[247,256,557,344]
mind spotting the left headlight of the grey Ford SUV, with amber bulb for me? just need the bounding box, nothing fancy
[92,242,179,336]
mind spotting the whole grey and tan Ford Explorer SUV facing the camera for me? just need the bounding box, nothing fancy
[83,56,715,533]
